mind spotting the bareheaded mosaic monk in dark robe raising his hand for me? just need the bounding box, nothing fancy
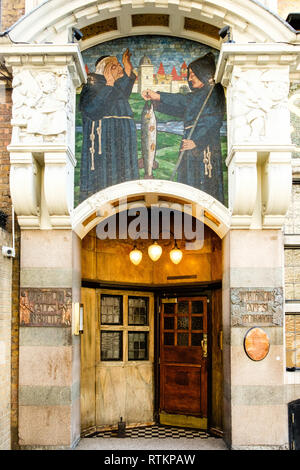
[80,49,139,202]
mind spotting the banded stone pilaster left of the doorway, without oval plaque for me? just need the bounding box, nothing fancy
[19,230,80,448]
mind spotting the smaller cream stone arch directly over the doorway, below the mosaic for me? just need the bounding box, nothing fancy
[72,180,230,239]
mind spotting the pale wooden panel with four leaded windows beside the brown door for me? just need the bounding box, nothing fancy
[96,289,154,428]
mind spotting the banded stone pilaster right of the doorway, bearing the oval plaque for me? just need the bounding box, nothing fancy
[223,230,288,449]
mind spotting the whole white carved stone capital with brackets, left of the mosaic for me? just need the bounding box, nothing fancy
[4,43,86,229]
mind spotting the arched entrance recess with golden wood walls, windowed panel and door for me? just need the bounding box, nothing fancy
[76,187,227,433]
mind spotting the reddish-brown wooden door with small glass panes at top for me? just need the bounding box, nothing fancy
[159,296,208,429]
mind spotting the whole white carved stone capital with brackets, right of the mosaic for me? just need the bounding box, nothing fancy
[215,43,300,229]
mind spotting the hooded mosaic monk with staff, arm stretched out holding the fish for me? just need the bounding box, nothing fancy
[142,52,225,203]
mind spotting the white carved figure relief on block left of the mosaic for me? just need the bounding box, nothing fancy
[13,70,69,142]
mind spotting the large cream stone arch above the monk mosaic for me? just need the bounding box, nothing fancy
[2,0,297,48]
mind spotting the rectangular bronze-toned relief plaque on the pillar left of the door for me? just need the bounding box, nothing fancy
[20,288,72,327]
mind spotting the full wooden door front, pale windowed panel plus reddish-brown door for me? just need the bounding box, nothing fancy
[81,288,223,431]
